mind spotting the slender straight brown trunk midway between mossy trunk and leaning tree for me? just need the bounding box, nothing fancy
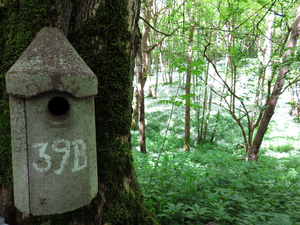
[184,13,195,152]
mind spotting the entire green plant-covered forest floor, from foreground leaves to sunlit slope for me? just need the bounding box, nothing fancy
[132,71,300,225]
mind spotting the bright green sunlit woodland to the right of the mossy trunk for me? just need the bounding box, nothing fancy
[132,0,300,224]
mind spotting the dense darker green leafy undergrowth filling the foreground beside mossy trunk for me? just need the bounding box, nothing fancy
[133,149,300,225]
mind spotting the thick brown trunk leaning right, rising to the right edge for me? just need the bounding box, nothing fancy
[246,3,300,161]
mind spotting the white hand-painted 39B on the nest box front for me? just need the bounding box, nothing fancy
[32,139,87,175]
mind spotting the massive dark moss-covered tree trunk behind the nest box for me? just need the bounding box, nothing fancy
[0,0,158,225]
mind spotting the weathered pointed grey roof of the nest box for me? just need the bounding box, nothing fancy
[6,27,98,98]
